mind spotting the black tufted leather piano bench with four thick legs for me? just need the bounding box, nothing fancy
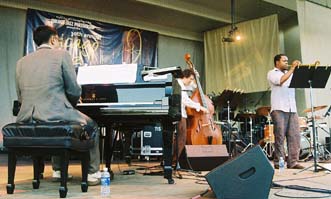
[2,122,95,198]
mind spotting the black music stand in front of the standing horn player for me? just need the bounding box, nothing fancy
[289,66,331,173]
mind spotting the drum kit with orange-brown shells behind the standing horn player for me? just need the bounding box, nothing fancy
[222,106,331,161]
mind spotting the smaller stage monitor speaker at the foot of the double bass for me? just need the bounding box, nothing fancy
[180,145,229,171]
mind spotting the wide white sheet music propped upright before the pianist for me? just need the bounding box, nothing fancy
[77,64,137,85]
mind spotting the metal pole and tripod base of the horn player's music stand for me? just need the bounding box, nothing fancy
[294,80,331,174]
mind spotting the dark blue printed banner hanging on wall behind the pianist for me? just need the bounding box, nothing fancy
[24,9,158,68]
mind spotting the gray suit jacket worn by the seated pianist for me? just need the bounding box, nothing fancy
[16,44,86,124]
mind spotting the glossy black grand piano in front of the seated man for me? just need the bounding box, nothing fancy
[77,67,181,184]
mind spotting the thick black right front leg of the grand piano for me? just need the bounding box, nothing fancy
[162,121,175,184]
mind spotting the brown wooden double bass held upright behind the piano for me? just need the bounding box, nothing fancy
[185,54,222,145]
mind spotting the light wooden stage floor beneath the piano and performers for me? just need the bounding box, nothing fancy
[0,154,331,199]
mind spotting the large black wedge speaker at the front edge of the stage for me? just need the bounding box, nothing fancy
[205,146,274,199]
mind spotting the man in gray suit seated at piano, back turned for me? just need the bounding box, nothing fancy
[16,26,100,185]
